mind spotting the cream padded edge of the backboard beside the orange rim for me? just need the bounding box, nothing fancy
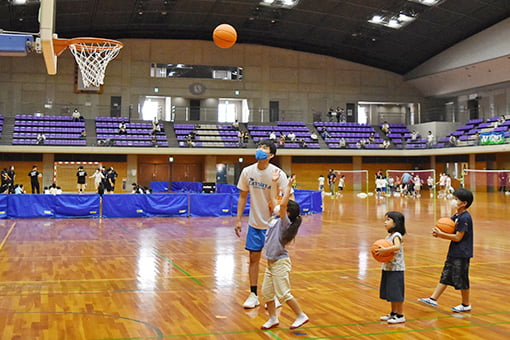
[39,0,57,75]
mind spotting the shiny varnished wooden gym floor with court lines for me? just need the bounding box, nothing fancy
[0,193,510,340]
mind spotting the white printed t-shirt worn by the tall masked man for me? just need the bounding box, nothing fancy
[237,163,289,229]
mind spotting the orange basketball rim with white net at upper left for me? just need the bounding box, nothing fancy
[53,38,124,87]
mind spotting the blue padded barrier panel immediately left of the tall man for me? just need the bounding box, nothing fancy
[189,194,232,217]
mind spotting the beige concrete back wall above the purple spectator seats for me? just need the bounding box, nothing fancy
[0,39,422,121]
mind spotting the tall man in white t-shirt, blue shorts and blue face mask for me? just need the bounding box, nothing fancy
[234,140,288,308]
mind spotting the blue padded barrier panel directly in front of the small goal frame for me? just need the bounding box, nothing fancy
[53,194,99,218]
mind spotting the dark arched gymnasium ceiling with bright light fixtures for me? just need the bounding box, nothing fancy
[0,0,510,74]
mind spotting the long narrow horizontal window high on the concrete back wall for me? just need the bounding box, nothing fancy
[151,63,243,80]
